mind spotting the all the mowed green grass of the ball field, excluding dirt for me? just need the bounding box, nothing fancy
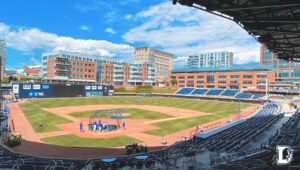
[21,96,248,147]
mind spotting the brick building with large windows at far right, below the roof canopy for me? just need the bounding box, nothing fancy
[260,46,300,83]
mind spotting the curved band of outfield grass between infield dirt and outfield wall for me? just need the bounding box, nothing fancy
[25,96,248,113]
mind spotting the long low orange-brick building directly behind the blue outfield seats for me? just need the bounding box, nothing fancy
[169,67,275,89]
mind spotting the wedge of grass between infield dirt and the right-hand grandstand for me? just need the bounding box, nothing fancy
[145,109,234,136]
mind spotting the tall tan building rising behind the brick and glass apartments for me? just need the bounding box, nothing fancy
[134,47,174,84]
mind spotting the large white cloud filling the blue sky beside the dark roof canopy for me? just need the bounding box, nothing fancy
[123,3,259,65]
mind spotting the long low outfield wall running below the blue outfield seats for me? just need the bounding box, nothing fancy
[114,93,260,104]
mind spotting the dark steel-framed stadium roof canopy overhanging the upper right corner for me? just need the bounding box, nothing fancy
[173,0,300,61]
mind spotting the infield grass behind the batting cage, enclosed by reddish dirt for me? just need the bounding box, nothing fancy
[70,108,171,120]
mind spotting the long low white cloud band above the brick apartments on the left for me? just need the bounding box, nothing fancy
[0,23,133,57]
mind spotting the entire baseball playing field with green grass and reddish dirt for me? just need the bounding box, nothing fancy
[8,84,258,158]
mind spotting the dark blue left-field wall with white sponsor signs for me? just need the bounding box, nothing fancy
[12,83,111,99]
